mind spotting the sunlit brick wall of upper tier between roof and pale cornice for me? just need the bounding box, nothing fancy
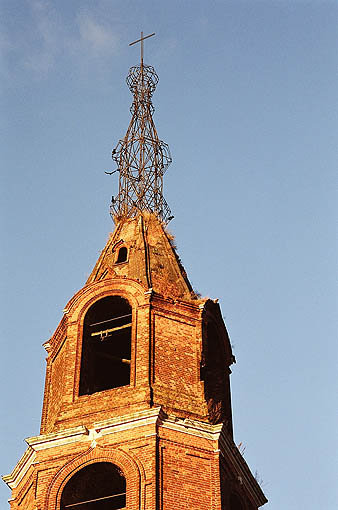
[41,279,235,433]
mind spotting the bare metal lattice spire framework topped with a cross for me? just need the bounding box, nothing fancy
[110,32,172,223]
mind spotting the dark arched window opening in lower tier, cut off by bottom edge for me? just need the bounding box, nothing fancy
[60,462,126,510]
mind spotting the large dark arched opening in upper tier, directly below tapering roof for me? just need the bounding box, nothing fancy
[79,296,132,395]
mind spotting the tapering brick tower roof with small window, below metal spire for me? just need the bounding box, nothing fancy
[87,212,195,299]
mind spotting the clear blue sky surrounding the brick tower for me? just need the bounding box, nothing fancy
[0,0,338,510]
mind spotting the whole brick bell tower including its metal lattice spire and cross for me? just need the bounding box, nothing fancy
[3,34,266,510]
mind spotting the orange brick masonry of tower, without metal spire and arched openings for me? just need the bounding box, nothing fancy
[6,215,265,510]
